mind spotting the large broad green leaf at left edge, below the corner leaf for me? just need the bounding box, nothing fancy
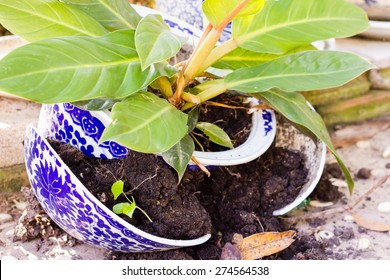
[0,30,175,103]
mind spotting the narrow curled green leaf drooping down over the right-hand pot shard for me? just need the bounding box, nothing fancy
[252,90,354,193]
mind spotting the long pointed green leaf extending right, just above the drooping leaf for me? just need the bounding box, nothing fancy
[225,51,374,92]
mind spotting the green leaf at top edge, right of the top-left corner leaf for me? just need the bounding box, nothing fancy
[62,0,141,31]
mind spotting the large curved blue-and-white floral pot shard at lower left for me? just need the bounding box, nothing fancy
[25,127,210,252]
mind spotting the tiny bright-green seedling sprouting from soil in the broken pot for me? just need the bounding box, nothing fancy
[111,180,153,223]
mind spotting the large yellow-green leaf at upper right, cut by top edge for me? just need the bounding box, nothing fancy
[232,0,369,54]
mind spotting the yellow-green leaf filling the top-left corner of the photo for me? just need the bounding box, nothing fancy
[0,0,107,42]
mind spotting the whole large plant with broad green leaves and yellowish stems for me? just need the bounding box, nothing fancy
[0,0,373,191]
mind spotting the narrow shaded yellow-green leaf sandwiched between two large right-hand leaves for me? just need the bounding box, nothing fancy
[213,45,316,70]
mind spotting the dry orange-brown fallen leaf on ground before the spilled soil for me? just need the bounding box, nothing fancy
[236,230,296,260]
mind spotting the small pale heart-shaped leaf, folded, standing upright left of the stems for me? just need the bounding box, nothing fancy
[135,15,187,69]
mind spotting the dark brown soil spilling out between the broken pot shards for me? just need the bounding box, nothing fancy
[52,136,307,259]
